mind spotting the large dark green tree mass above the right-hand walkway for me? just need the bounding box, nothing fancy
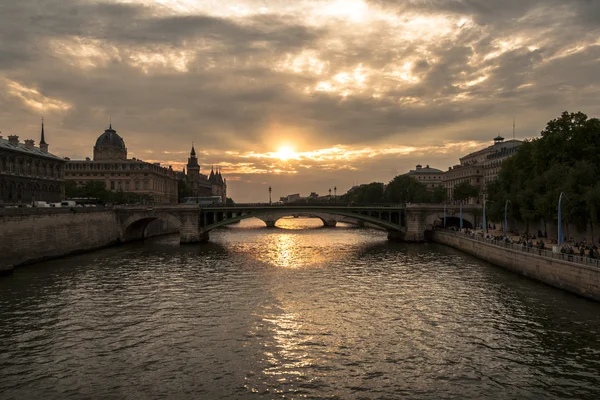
[487,112,600,236]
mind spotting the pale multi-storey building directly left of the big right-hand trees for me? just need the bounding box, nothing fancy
[442,136,523,204]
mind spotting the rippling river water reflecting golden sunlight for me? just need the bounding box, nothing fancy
[0,218,600,399]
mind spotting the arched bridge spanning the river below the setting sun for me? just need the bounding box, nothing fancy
[115,204,481,243]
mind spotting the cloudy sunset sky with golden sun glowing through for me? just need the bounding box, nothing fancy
[0,0,600,202]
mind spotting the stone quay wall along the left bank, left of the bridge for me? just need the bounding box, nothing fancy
[0,207,120,272]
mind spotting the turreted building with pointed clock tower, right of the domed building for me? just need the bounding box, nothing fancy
[183,145,227,203]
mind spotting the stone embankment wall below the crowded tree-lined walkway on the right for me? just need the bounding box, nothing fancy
[432,231,600,301]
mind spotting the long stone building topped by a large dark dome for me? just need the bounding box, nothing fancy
[65,124,177,204]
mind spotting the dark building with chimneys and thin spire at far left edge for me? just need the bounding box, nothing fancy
[0,122,66,204]
